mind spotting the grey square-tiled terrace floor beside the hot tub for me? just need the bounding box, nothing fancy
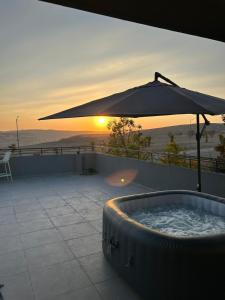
[0,174,153,300]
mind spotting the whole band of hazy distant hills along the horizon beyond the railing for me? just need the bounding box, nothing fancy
[0,123,225,157]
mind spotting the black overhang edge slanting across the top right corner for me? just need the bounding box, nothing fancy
[41,0,225,42]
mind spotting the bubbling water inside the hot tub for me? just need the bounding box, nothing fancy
[131,205,225,236]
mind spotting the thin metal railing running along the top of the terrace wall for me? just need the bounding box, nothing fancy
[0,145,225,173]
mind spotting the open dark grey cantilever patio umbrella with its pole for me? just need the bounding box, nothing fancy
[39,72,225,191]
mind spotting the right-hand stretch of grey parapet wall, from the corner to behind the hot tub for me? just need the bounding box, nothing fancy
[96,154,225,197]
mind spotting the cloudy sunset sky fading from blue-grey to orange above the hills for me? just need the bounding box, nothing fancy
[0,0,225,130]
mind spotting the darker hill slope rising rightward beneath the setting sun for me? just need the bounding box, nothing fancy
[18,123,225,157]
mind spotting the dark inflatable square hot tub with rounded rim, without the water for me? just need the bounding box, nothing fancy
[102,191,225,300]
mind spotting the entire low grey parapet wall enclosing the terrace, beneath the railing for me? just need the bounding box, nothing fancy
[7,153,225,197]
